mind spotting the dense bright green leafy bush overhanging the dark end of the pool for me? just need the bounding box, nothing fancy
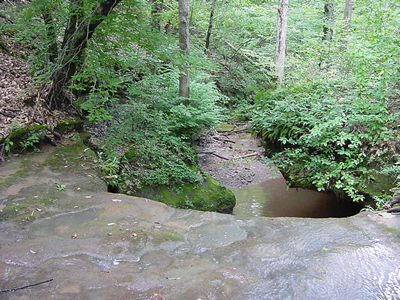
[252,83,399,201]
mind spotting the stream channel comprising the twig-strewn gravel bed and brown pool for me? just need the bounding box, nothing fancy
[198,122,362,218]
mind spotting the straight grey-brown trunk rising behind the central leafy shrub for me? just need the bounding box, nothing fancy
[179,0,190,101]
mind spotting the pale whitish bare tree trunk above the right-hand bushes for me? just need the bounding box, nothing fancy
[275,0,289,87]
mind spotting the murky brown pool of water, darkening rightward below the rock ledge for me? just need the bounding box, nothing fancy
[233,177,362,218]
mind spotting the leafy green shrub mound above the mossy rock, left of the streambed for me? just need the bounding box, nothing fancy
[95,74,220,194]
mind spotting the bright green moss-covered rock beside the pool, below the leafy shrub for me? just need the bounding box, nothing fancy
[135,174,236,213]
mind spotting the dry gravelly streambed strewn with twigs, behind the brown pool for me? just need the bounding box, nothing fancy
[197,122,279,189]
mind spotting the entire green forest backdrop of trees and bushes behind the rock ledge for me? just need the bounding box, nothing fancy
[0,0,400,208]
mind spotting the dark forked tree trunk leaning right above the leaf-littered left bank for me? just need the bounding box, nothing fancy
[47,0,121,109]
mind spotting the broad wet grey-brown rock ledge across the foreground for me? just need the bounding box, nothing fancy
[0,140,400,300]
